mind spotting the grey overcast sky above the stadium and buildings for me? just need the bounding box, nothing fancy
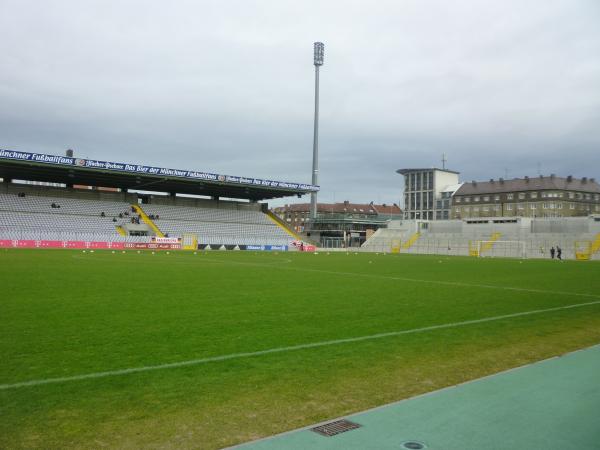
[0,0,600,203]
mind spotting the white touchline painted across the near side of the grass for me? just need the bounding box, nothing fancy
[0,300,600,390]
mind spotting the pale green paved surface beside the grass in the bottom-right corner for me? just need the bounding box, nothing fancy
[236,346,600,450]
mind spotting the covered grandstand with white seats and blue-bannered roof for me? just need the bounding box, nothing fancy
[0,151,314,249]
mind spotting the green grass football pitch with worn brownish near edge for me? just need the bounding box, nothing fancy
[0,250,600,449]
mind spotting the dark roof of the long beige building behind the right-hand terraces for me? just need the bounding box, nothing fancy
[454,175,600,195]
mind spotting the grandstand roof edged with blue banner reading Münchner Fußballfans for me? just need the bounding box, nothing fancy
[0,149,319,200]
